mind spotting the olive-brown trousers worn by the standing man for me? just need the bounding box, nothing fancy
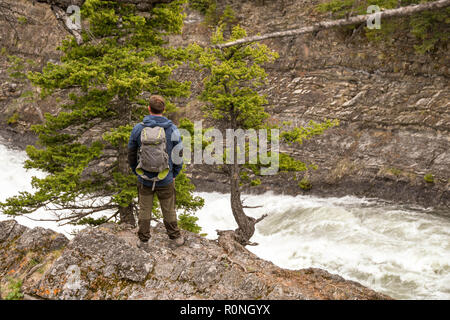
[138,182,181,241]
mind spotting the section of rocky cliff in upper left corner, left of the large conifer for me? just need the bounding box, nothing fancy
[0,0,69,147]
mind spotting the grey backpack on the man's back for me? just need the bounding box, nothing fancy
[136,126,169,190]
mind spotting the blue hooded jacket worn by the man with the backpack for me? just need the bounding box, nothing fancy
[128,115,183,187]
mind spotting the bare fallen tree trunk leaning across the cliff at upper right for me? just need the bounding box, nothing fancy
[214,0,450,48]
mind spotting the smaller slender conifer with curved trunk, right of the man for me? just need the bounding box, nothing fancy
[195,24,337,245]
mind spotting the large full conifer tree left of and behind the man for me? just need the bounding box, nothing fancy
[0,0,203,225]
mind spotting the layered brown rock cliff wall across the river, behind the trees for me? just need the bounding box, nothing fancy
[0,0,450,208]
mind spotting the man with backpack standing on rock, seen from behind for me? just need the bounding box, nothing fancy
[128,95,184,249]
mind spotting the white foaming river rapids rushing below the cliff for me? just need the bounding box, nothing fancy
[0,143,450,299]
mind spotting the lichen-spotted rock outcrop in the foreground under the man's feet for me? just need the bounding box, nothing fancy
[0,220,389,299]
